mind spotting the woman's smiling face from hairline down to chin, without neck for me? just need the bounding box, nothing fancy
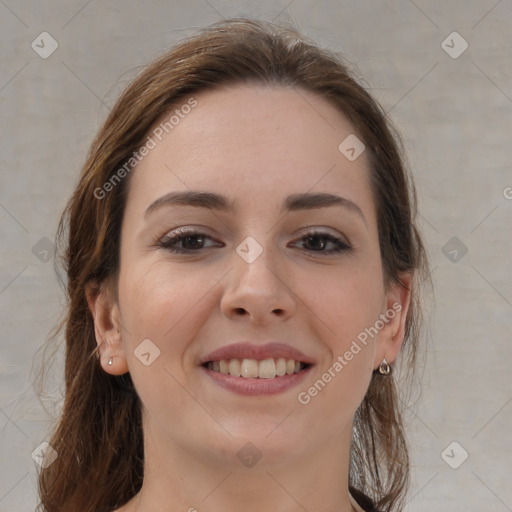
[95,85,403,472]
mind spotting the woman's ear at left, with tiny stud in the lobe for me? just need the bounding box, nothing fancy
[85,283,129,375]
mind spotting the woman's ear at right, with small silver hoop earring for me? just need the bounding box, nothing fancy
[373,272,413,369]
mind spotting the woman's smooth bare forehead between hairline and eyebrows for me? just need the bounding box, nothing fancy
[123,84,370,218]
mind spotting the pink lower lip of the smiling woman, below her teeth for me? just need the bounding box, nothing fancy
[201,366,312,396]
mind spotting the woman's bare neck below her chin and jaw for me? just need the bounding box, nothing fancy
[125,412,354,512]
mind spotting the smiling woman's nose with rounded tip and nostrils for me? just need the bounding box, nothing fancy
[221,239,297,324]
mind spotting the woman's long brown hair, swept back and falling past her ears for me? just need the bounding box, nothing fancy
[34,19,428,512]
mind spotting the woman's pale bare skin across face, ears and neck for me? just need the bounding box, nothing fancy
[88,85,411,512]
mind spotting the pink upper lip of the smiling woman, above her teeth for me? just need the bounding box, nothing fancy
[199,341,314,364]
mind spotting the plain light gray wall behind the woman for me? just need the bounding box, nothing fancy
[0,0,512,512]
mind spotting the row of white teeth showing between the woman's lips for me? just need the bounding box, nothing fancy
[206,357,304,379]
